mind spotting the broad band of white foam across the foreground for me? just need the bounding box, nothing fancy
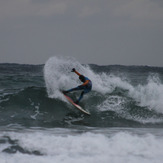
[0,129,163,163]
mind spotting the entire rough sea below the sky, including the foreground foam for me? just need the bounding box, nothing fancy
[0,56,163,163]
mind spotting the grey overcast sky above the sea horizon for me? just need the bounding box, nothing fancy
[0,0,163,66]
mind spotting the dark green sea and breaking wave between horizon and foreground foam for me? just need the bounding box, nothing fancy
[0,57,163,128]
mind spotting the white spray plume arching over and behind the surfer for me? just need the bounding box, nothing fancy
[44,57,114,98]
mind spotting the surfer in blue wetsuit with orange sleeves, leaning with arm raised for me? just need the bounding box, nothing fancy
[63,68,92,104]
